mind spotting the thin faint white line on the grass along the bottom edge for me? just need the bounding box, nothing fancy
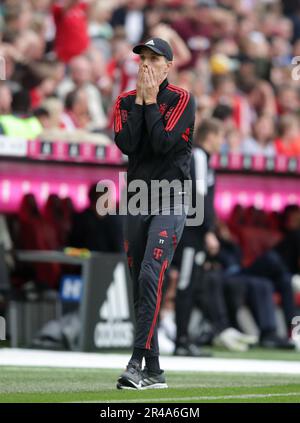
[72,391,300,403]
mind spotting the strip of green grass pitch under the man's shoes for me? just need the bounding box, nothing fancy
[0,367,300,403]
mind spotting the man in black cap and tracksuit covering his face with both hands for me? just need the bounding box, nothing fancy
[114,38,195,389]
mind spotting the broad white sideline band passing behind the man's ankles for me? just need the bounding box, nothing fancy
[0,348,300,376]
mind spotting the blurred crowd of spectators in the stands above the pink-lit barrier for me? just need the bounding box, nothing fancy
[0,0,300,156]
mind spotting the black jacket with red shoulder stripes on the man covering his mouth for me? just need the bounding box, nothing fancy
[114,79,195,202]
